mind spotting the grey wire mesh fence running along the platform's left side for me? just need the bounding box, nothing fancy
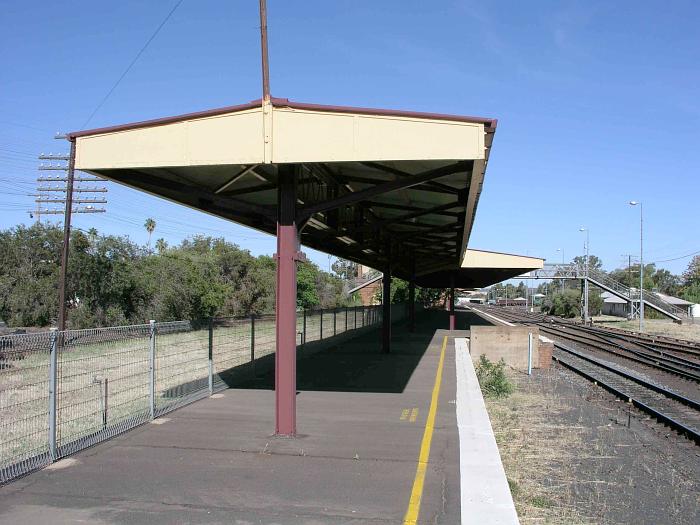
[0,305,388,484]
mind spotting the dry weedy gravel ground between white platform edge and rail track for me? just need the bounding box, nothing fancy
[486,365,700,525]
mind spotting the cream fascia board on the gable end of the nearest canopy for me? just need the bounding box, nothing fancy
[73,99,486,171]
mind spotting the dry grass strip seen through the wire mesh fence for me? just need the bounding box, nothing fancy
[0,311,378,468]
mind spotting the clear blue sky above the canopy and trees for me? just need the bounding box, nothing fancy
[0,0,700,273]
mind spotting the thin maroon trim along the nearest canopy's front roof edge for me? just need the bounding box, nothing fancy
[67,97,498,139]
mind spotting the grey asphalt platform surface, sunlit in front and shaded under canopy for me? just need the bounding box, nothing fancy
[0,312,492,524]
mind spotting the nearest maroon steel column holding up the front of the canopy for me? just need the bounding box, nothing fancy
[275,165,299,436]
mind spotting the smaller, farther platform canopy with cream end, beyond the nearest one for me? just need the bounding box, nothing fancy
[416,248,544,288]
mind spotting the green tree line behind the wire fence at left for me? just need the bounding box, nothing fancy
[0,224,352,328]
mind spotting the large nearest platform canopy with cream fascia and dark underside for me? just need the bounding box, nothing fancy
[69,98,496,280]
